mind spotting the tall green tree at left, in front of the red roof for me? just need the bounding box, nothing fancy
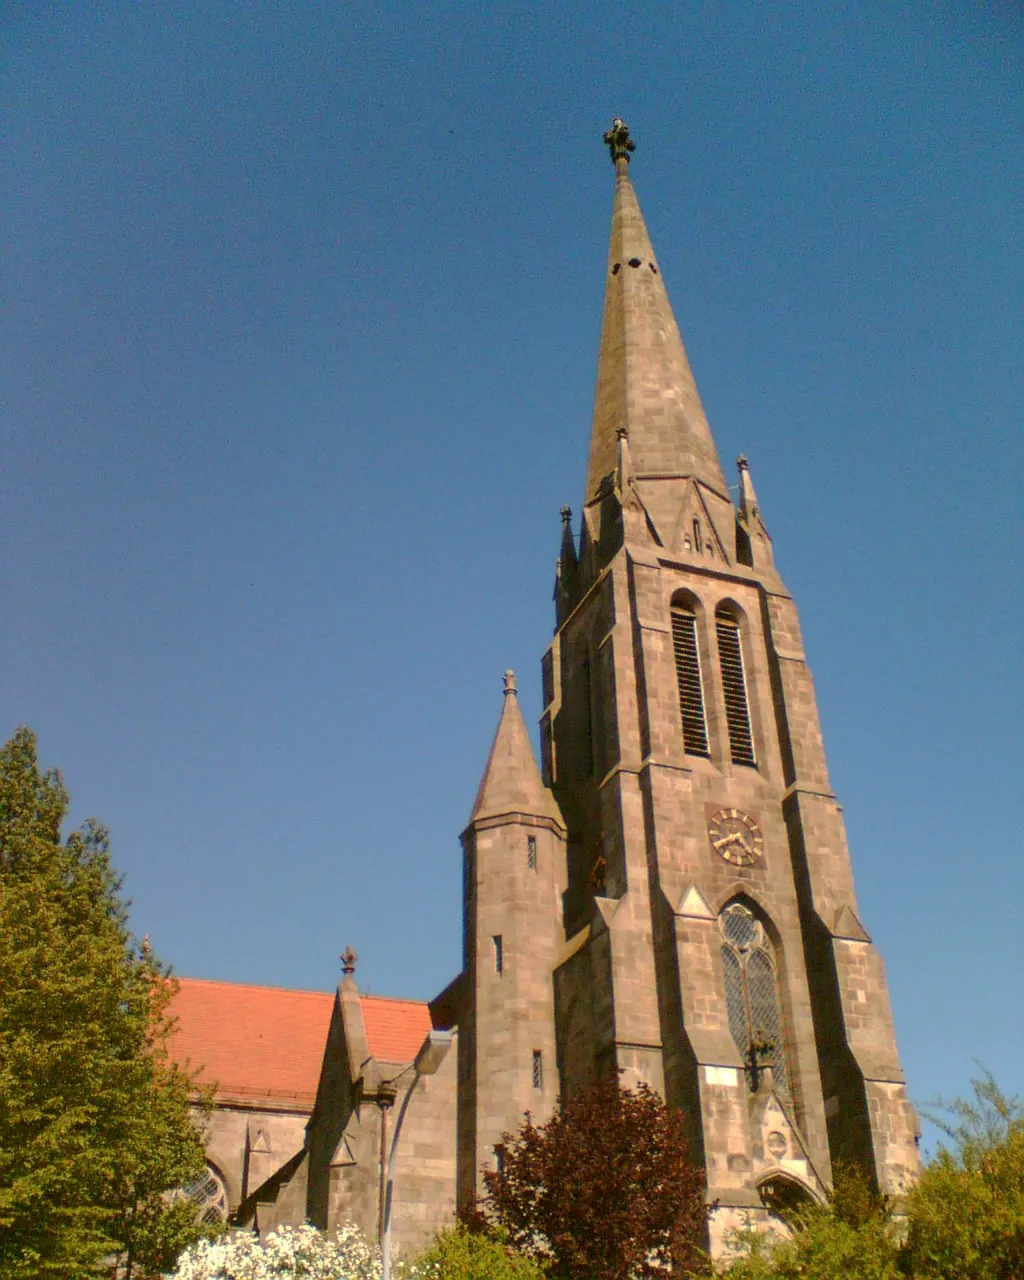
[0,728,211,1280]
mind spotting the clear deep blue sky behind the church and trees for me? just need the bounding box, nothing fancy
[0,0,1024,1136]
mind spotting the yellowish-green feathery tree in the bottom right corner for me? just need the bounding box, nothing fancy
[904,1071,1024,1280]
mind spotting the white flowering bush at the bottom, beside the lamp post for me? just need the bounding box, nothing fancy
[172,1224,399,1280]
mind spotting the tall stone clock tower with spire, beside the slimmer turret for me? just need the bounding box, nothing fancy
[535,120,918,1244]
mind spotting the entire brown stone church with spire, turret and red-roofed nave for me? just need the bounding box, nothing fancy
[166,119,918,1253]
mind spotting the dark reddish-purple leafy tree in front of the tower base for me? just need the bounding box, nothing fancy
[484,1078,708,1280]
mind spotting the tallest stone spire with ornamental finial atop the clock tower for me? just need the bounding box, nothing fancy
[586,119,728,503]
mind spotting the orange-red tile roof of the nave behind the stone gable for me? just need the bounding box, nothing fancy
[169,978,430,1110]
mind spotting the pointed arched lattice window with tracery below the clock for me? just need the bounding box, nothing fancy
[718,902,790,1093]
